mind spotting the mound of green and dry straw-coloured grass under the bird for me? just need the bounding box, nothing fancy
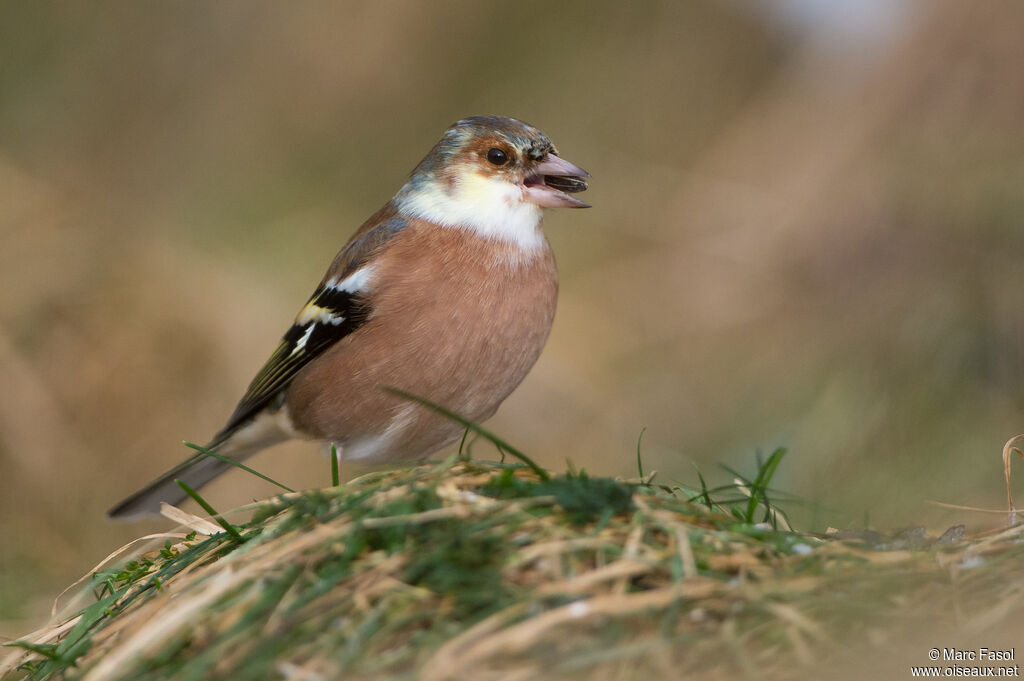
[0,455,1024,681]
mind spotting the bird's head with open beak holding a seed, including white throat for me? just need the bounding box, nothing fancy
[395,116,590,247]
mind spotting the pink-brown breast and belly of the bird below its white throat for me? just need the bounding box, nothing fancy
[287,221,558,461]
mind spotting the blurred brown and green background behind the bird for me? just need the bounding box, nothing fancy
[0,0,1024,636]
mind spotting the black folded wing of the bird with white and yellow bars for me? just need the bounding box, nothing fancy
[211,204,409,445]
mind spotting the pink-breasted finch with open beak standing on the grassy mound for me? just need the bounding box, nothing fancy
[108,116,590,519]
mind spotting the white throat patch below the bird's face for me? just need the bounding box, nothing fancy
[395,174,545,251]
